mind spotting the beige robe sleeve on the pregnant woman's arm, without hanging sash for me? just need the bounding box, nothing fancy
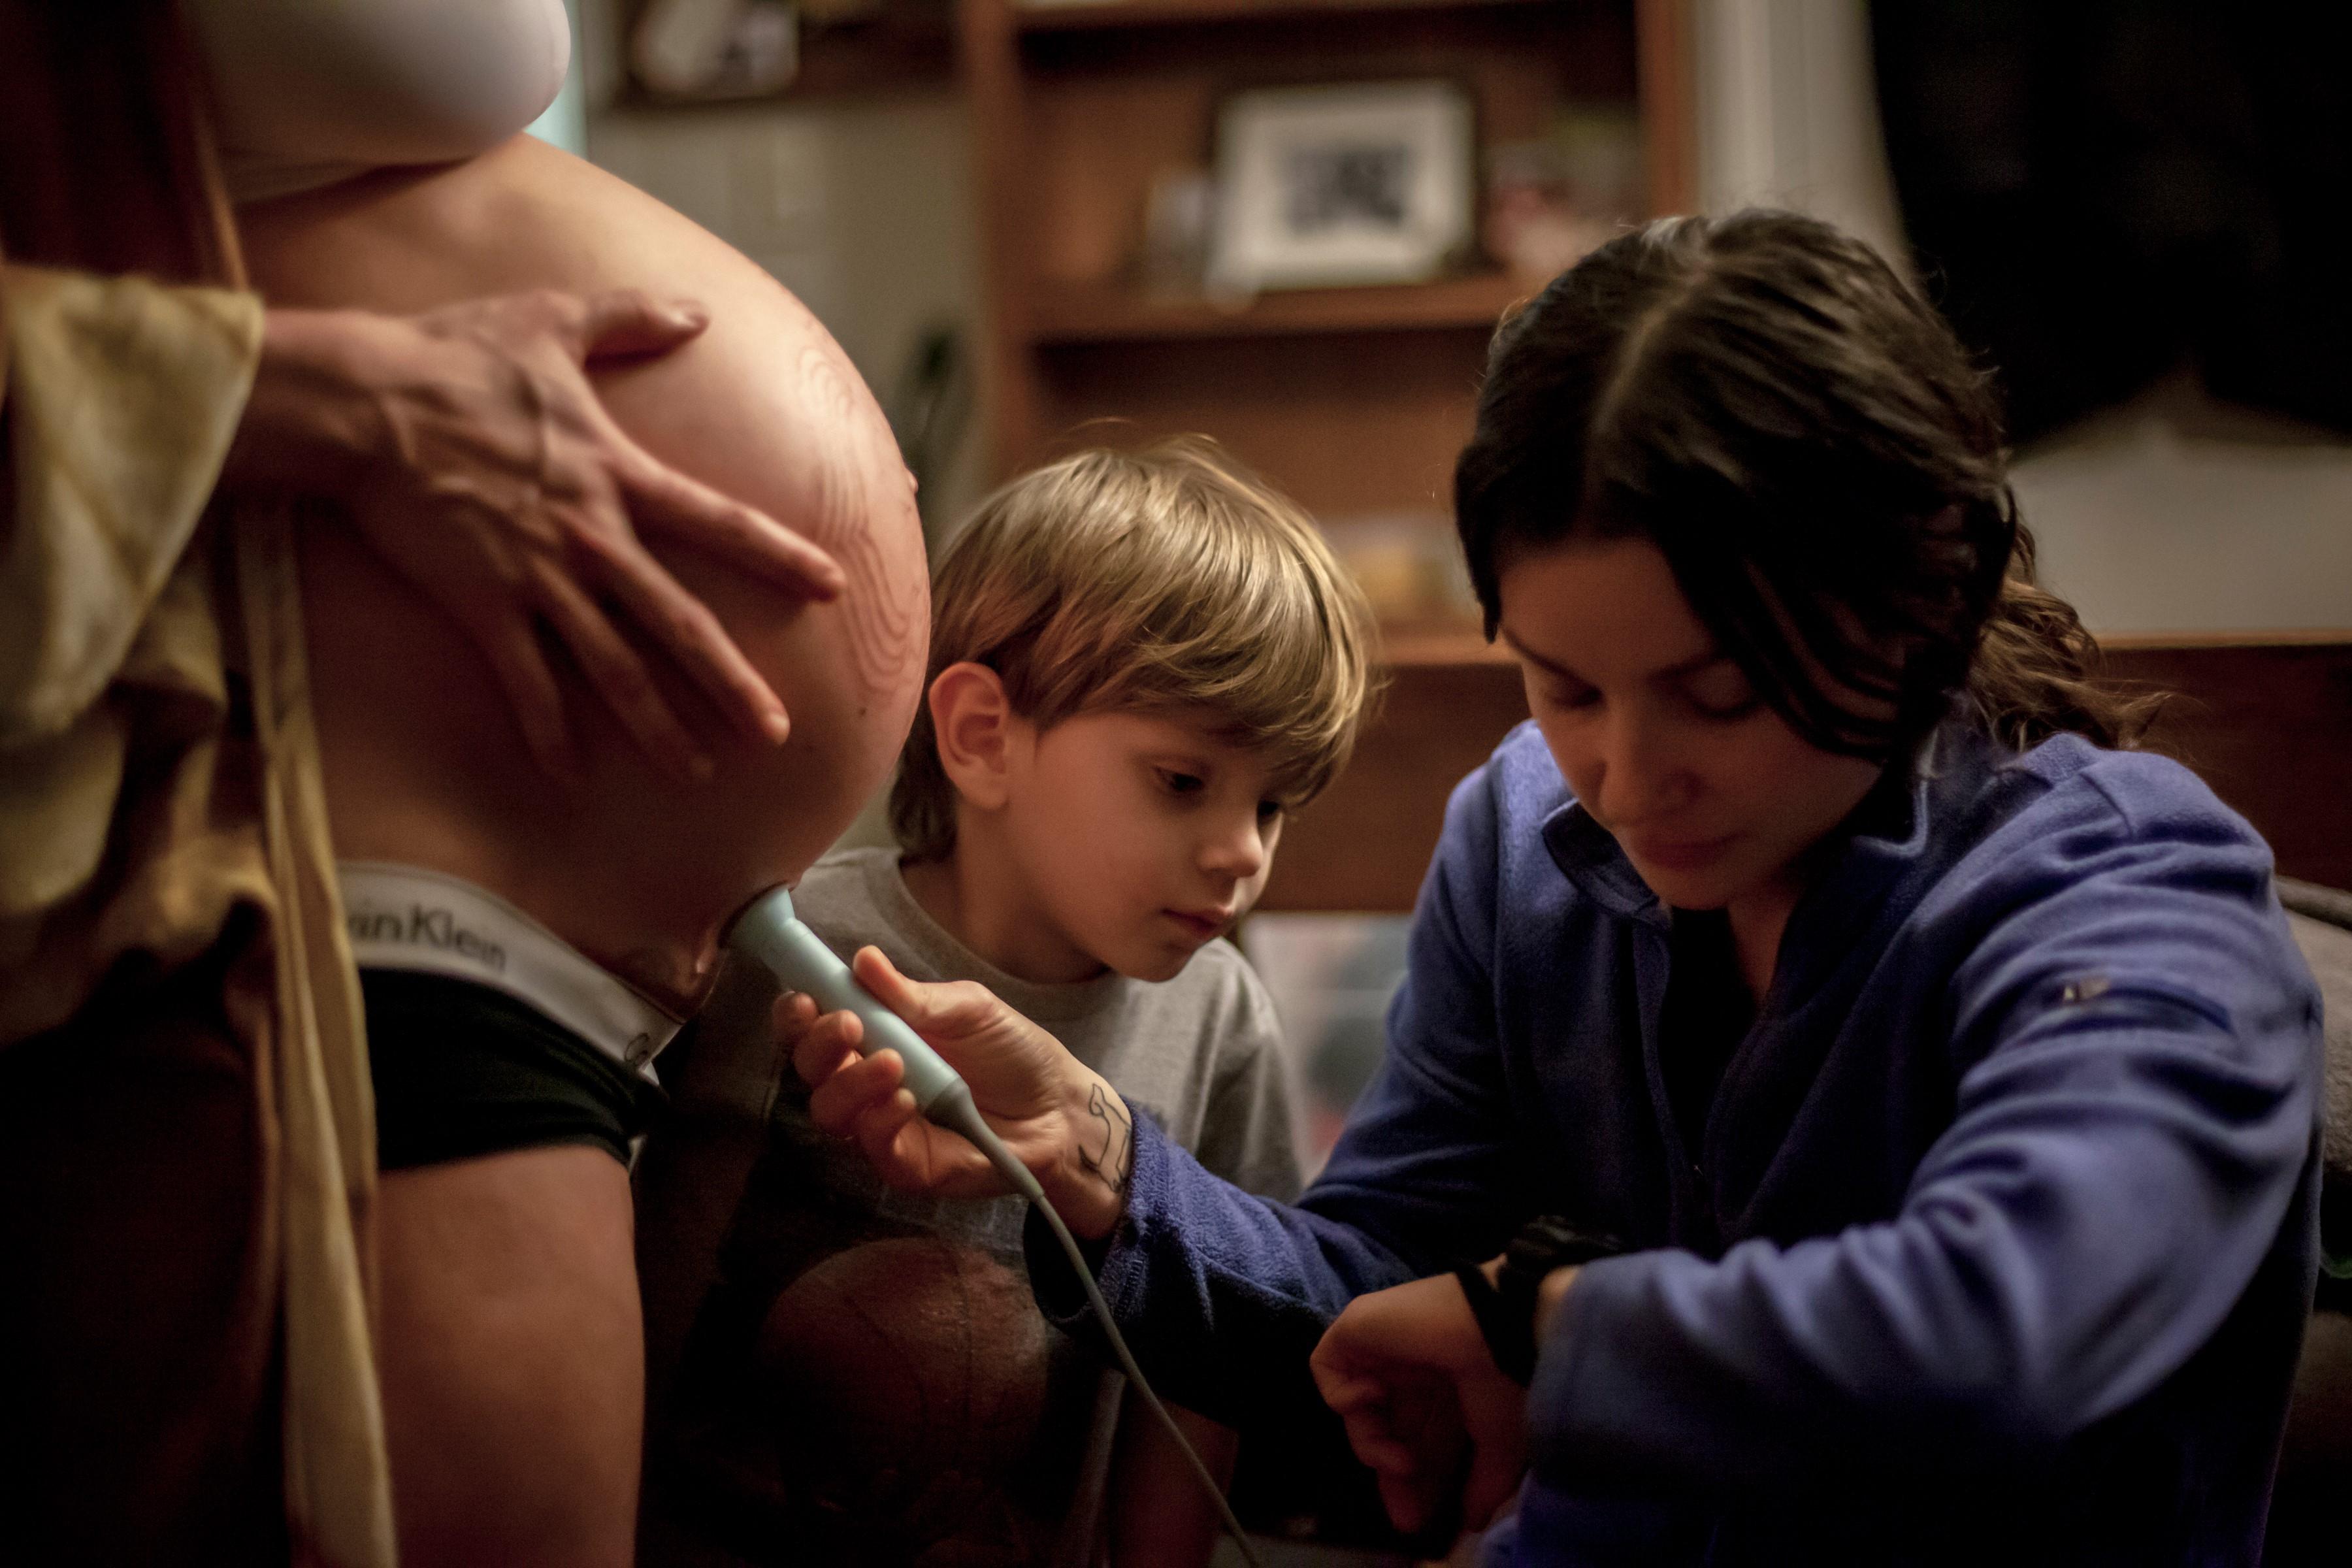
[0,266,261,1020]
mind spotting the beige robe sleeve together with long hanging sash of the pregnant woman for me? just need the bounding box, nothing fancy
[0,266,395,1568]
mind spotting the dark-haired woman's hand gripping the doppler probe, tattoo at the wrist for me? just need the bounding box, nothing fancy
[776,947,1134,1239]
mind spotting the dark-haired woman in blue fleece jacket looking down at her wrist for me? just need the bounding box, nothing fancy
[781,214,2319,1563]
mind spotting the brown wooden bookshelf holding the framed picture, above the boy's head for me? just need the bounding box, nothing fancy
[957,0,1691,519]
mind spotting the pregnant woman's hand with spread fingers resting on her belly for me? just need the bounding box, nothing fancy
[223,289,842,776]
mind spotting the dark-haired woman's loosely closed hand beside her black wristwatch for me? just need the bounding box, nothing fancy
[1310,1274,1526,1533]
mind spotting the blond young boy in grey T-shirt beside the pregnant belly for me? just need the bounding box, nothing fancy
[640,442,1369,1568]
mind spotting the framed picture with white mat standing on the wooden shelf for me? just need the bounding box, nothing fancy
[1209,80,1477,294]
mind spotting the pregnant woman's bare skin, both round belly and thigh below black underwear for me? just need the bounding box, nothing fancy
[242,139,929,1563]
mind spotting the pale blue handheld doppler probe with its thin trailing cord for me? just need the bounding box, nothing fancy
[727,887,1263,1568]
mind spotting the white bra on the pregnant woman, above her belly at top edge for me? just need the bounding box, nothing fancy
[181,0,572,202]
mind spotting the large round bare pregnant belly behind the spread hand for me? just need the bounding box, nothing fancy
[242,139,929,962]
